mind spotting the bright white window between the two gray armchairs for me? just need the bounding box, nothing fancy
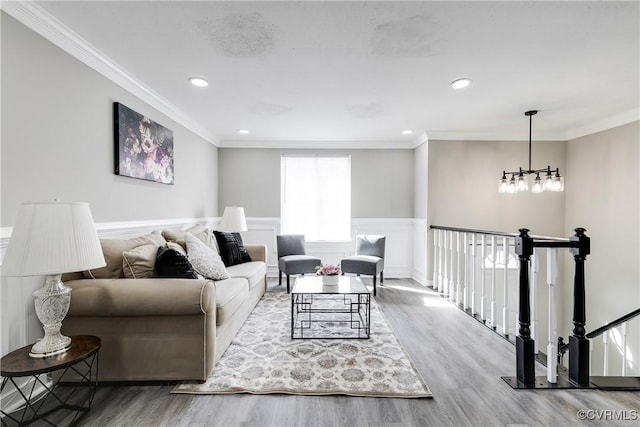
[280,155,351,241]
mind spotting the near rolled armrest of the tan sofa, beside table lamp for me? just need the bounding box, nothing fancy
[65,278,216,316]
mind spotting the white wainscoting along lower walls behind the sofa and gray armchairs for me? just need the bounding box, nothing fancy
[0,217,426,355]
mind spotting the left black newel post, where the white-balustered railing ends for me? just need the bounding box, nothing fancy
[516,228,536,387]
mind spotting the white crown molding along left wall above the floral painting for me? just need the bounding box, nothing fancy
[0,0,219,146]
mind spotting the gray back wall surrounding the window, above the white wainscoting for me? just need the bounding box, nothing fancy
[219,148,414,218]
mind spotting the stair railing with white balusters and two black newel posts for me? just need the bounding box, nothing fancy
[431,225,590,387]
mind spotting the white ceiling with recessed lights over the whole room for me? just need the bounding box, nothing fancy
[3,1,640,148]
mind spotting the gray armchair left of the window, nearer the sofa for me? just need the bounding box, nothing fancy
[276,234,322,293]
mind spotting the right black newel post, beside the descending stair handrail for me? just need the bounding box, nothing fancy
[569,228,591,386]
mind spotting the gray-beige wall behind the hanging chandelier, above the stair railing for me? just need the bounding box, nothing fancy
[428,141,573,236]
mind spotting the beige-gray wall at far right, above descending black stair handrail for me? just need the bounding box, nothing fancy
[564,122,640,375]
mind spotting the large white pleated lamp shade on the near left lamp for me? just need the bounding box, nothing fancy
[2,201,106,276]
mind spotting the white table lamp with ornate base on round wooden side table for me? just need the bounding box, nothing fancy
[2,201,106,358]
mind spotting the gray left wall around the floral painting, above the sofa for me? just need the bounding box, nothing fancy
[1,13,218,227]
